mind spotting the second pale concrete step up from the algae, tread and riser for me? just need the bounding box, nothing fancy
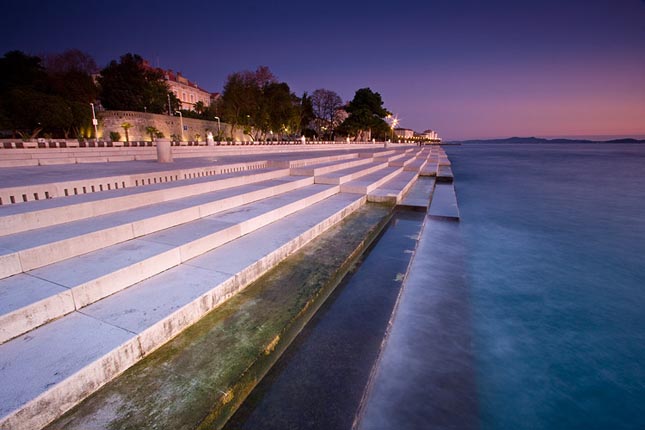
[0,185,339,342]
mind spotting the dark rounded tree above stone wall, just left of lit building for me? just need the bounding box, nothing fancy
[99,54,171,113]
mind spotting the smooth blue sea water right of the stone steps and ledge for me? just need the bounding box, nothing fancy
[446,144,645,430]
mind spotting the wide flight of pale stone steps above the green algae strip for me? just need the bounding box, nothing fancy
[0,147,451,429]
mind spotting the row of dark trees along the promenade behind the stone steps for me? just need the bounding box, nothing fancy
[0,50,390,140]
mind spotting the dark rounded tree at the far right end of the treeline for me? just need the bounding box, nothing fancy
[339,88,390,139]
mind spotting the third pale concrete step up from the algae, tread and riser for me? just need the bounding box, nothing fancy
[0,176,313,278]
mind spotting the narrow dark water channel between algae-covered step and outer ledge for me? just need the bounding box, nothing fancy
[225,210,425,430]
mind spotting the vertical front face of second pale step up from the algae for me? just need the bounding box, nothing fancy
[0,186,340,344]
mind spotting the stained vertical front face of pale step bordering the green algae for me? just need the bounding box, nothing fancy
[0,196,367,430]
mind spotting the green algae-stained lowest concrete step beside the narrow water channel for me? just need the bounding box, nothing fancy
[47,204,391,430]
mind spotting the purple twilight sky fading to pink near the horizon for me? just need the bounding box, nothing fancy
[0,0,645,139]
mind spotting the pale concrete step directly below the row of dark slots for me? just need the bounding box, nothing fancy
[0,169,289,235]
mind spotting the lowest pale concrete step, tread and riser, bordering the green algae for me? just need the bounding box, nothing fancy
[0,194,366,430]
